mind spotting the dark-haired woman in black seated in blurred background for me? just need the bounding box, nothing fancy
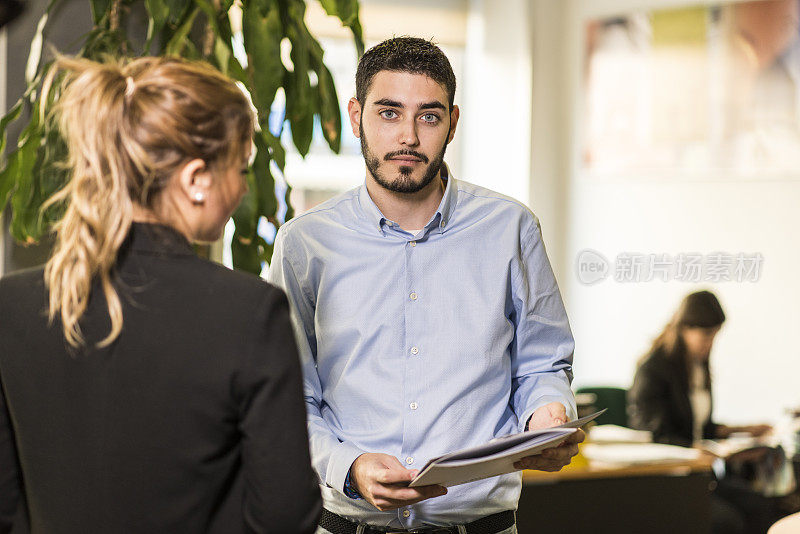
[628,291,771,447]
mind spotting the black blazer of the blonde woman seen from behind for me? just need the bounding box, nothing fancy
[0,224,321,534]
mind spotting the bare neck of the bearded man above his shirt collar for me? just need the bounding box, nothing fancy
[367,171,444,230]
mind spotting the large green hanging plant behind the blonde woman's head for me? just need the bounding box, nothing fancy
[0,0,364,273]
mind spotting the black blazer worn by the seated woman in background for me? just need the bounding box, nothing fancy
[628,352,716,447]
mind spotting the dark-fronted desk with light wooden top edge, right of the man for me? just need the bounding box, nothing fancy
[517,458,714,534]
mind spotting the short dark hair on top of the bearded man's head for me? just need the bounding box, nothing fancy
[356,37,456,109]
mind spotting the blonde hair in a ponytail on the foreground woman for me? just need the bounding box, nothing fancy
[42,57,253,348]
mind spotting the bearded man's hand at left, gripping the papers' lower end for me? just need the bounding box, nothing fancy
[350,453,447,511]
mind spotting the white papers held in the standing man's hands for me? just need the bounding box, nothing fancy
[409,410,605,488]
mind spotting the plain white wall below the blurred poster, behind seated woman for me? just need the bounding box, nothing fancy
[568,180,800,428]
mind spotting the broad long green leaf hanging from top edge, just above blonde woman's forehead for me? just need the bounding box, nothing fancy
[242,0,284,120]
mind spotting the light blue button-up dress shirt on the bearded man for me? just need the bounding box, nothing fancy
[268,169,575,528]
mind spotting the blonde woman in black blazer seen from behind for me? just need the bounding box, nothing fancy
[0,58,320,534]
